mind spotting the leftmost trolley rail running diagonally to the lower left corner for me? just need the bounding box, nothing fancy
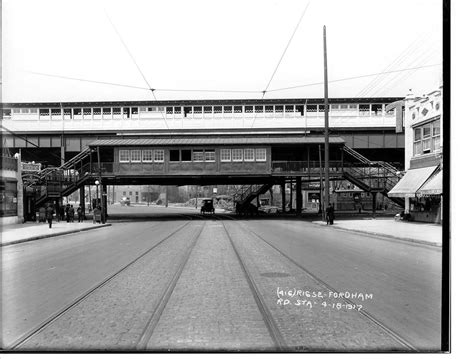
[11,221,196,350]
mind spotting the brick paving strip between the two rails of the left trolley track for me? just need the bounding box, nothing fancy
[20,222,201,351]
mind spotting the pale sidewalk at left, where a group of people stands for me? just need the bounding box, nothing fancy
[0,221,110,247]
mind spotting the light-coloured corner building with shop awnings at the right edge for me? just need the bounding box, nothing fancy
[389,86,443,223]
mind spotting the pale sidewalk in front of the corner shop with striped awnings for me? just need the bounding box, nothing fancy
[312,218,443,247]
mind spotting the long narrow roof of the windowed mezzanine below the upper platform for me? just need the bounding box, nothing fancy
[89,136,345,147]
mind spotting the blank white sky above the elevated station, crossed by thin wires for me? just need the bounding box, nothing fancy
[2,0,443,102]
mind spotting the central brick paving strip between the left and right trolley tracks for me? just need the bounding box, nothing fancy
[148,222,273,350]
